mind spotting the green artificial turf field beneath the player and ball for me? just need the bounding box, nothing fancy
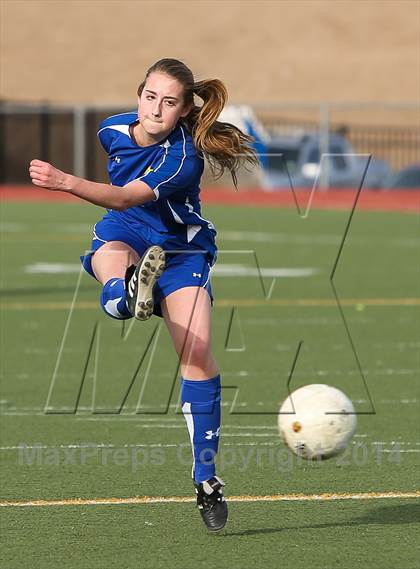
[0,199,420,569]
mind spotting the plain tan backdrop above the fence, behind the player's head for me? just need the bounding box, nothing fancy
[0,0,420,105]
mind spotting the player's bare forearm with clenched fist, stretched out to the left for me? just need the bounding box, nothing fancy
[29,160,156,211]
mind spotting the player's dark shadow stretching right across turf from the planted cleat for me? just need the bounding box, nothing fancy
[221,502,420,537]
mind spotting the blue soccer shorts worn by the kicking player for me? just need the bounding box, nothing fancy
[80,218,213,316]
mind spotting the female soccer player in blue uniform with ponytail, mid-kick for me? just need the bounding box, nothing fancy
[29,59,256,531]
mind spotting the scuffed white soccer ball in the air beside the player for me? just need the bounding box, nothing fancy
[278,384,357,460]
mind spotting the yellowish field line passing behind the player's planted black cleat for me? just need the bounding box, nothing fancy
[0,490,420,507]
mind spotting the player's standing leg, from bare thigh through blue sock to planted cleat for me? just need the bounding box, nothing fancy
[161,287,228,531]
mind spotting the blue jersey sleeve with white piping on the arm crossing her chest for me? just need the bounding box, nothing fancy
[138,149,204,201]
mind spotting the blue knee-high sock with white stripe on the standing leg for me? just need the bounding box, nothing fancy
[181,375,221,482]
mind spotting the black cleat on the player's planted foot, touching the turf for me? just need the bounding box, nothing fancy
[194,476,228,531]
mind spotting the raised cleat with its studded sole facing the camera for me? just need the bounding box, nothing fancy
[125,245,166,320]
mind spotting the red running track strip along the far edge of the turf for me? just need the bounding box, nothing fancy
[0,186,420,213]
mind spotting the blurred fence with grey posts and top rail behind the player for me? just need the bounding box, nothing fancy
[0,102,420,184]
